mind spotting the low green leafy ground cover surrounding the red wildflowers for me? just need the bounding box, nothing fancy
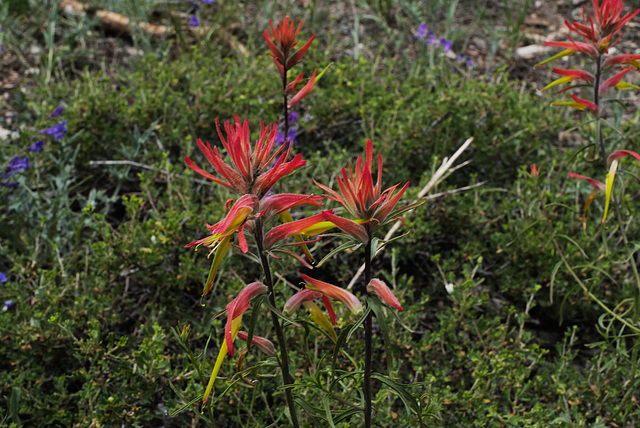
[0,1,640,427]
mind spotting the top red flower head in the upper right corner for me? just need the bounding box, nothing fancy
[538,0,640,114]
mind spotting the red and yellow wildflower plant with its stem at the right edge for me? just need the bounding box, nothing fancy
[538,0,640,322]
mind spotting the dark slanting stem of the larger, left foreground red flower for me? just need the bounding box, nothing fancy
[254,218,300,428]
